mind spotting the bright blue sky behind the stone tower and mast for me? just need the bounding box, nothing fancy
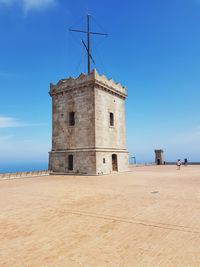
[0,0,200,168]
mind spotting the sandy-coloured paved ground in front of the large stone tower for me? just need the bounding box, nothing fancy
[0,166,200,267]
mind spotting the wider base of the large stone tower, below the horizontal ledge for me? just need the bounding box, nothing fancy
[49,149,128,175]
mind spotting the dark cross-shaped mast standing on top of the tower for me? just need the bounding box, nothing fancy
[69,15,108,74]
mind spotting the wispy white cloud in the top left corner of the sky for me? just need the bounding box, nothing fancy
[0,0,57,13]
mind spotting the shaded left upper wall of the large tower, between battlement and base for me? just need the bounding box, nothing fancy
[52,87,95,150]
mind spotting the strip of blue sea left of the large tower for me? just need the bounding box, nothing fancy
[0,162,48,173]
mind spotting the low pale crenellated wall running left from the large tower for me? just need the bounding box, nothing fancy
[0,170,49,180]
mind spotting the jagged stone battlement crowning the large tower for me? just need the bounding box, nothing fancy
[49,69,127,98]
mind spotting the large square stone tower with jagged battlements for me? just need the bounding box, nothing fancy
[49,70,128,175]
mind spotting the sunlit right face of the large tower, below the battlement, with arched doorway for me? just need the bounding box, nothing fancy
[95,84,128,174]
